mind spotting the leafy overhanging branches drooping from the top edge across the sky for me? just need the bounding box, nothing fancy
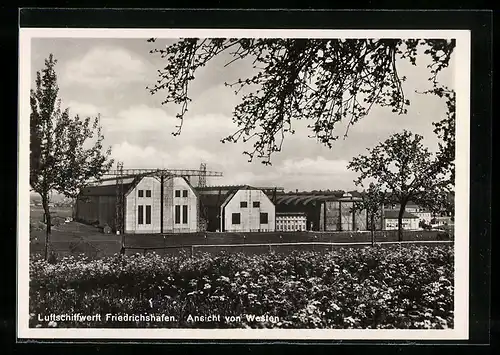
[146,38,455,164]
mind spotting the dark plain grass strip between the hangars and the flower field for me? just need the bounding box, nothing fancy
[30,206,454,259]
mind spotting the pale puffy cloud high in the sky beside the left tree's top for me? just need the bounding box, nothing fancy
[62,46,147,89]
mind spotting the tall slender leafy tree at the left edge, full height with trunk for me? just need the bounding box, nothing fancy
[30,54,113,259]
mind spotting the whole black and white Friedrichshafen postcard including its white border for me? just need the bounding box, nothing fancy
[18,28,470,340]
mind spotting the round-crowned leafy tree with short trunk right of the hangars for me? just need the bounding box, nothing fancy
[348,130,453,241]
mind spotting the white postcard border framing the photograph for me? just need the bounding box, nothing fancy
[17,28,471,340]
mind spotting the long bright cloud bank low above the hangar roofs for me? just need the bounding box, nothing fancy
[112,141,355,191]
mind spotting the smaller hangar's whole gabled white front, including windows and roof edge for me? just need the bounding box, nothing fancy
[220,187,276,232]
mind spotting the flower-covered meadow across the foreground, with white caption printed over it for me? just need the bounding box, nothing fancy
[29,244,454,329]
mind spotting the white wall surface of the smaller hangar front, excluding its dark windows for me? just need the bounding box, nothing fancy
[224,190,275,232]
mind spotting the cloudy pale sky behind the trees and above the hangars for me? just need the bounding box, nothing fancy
[31,38,453,190]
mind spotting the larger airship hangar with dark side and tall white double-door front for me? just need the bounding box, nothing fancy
[75,176,199,234]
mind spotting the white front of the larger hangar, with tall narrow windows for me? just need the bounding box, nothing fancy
[125,176,198,234]
